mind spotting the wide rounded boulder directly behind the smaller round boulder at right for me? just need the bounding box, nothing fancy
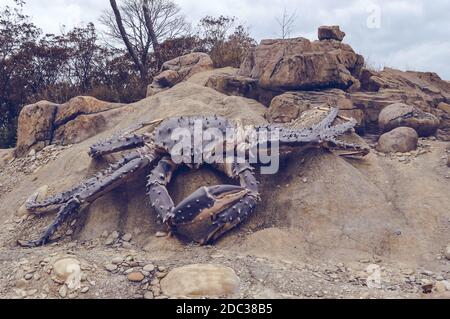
[378,103,440,136]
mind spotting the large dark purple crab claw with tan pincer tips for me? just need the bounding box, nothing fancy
[168,185,250,244]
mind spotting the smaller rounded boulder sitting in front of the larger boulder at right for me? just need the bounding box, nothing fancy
[376,127,419,153]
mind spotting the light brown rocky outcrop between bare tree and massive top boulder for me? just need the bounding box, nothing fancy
[147,52,213,96]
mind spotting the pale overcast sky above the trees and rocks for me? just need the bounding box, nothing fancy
[0,0,450,80]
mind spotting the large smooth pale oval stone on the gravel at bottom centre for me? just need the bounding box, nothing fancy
[161,264,240,297]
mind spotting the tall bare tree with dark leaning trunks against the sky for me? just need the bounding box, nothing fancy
[101,0,189,84]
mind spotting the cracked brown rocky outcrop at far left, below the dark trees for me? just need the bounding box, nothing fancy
[15,96,123,157]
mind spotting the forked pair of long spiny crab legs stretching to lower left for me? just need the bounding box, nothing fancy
[19,152,157,248]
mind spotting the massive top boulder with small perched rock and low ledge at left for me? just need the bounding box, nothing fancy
[208,27,364,106]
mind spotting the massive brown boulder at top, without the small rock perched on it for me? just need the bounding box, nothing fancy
[238,34,364,92]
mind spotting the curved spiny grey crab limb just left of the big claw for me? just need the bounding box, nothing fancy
[147,157,178,223]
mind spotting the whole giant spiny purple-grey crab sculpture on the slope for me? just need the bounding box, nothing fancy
[19,109,369,248]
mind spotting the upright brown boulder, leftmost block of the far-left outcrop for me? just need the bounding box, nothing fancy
[15,101,58,157]
